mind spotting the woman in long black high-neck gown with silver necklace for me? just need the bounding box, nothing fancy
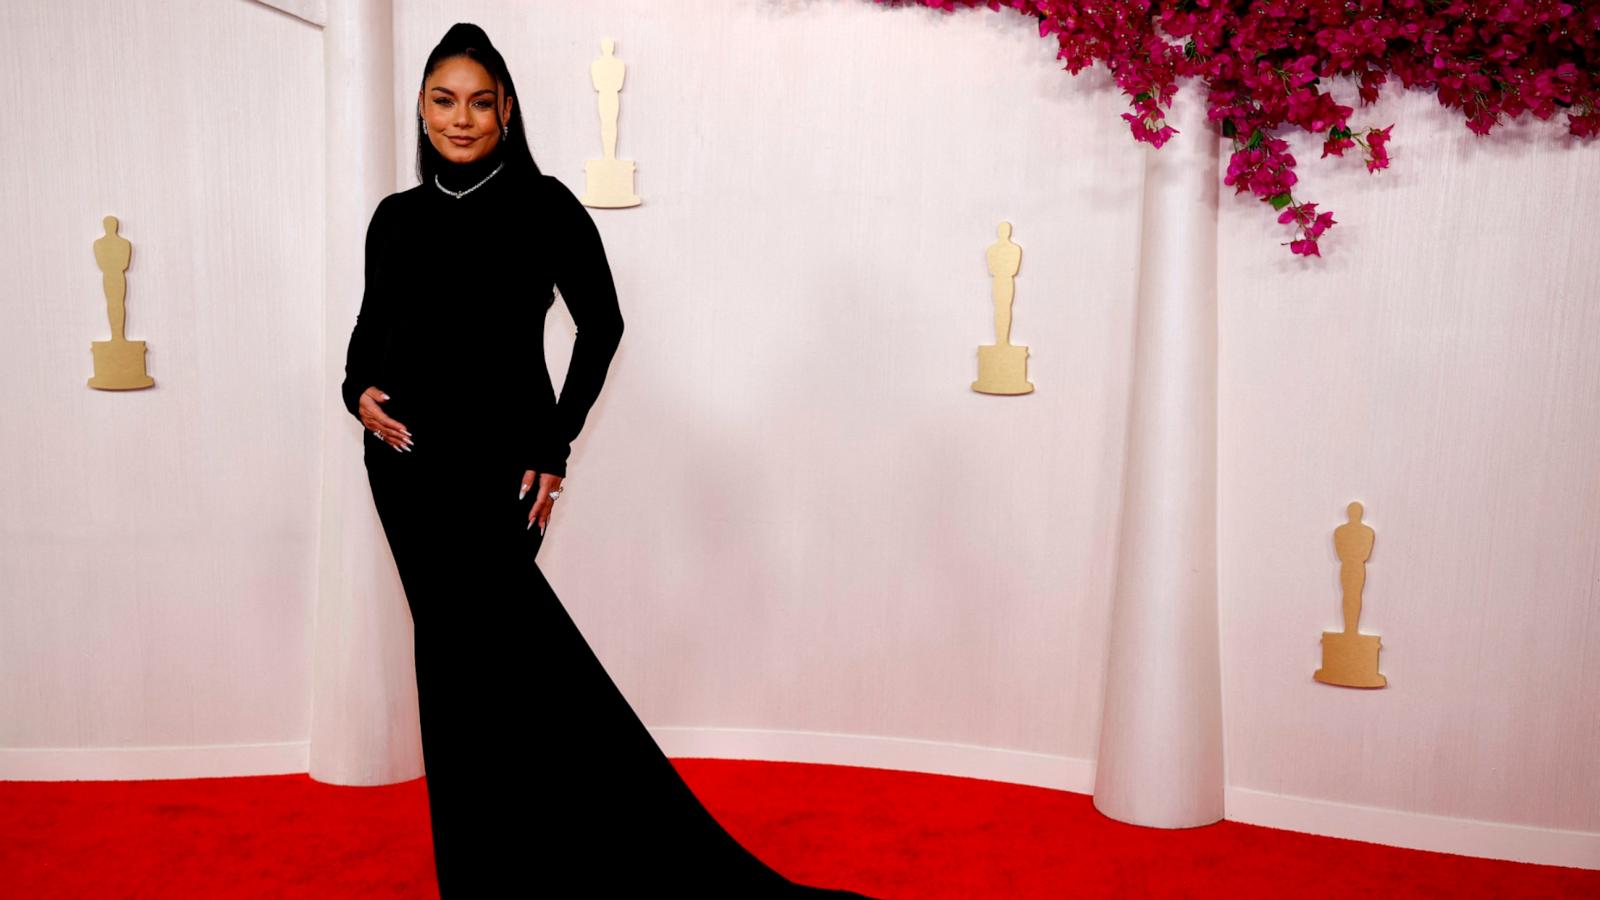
[342,24,861,900]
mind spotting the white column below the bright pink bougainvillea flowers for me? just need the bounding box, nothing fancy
[1094,82,1224,828]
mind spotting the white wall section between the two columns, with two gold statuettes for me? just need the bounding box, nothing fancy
[397,3,1142,756]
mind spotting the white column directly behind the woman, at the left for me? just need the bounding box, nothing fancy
[309,0,422,785]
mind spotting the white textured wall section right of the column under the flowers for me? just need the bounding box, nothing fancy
[1218,82,1600,831]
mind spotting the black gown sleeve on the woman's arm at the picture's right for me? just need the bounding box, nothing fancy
[528,176,622,476]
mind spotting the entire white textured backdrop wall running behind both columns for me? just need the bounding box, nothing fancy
[0,0,1600,865]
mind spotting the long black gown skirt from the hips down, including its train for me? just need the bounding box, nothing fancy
[366,434,862,900]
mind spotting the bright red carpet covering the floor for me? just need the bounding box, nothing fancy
[0,759,1600,900]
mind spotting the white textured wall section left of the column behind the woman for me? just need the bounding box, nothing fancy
[0,0,325,762]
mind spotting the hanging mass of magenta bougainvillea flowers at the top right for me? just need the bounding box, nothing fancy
[875,0,1600,256]
